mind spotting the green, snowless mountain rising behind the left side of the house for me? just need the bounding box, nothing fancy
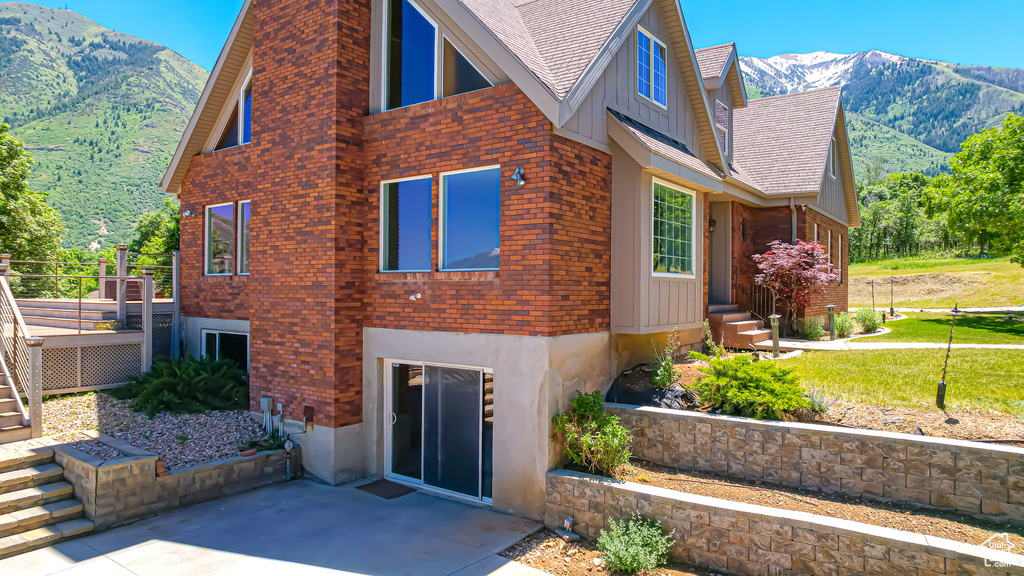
[0,2,207,249]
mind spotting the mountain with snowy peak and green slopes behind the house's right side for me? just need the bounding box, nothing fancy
[740,50,1024,180]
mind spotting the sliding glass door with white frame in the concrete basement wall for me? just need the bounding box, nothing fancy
[386,361,494,500]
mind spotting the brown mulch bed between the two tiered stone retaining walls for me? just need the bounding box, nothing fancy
[617,460,1024,549]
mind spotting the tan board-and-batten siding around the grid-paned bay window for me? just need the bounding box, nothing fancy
[611,143,705,334]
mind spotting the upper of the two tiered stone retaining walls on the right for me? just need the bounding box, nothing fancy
[607,404,1024,524]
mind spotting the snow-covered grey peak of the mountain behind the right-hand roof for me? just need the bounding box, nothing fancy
[739,50,909,94]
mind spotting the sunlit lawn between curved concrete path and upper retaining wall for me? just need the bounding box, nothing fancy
[779,349,1024,414]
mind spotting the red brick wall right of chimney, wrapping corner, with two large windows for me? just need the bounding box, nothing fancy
[365,84,611,336]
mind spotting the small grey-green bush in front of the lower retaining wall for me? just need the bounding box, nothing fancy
[597,512,675,574]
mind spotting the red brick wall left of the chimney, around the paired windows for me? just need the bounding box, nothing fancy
[179,145,252,320]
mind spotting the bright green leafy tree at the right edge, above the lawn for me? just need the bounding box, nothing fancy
[928,114,1024,256]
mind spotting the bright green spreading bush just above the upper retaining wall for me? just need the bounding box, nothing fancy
[690,353,814,420]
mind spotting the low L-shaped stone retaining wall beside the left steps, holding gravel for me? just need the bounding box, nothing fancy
[53,433,302,529]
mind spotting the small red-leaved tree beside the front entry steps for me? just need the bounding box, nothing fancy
[754,240,839,330]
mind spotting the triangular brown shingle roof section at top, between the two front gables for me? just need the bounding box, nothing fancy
[460,0,643,99]
